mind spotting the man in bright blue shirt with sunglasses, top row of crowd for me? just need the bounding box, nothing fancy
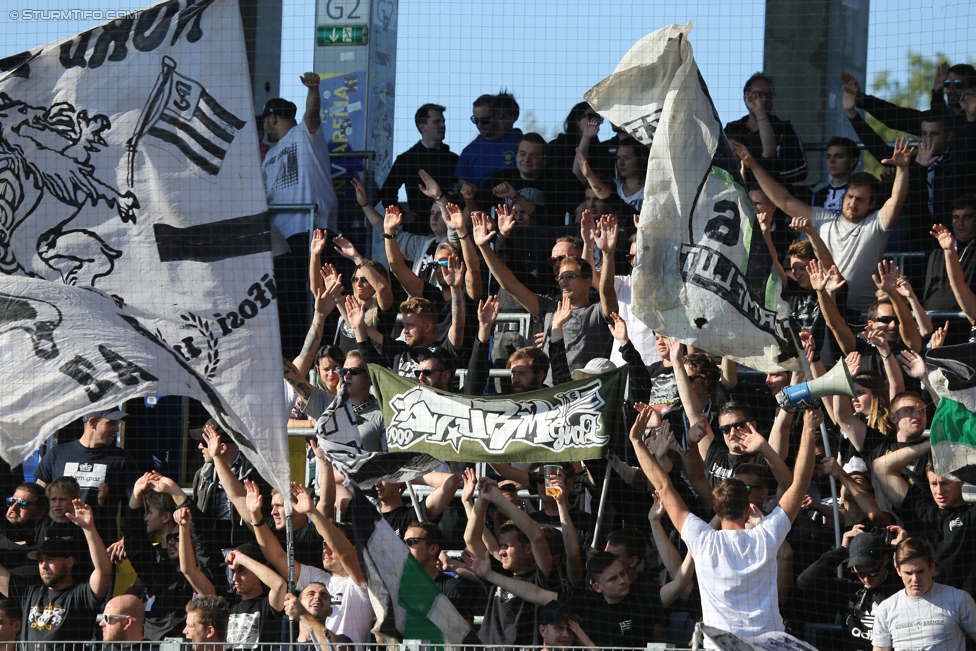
[454,95,522,187]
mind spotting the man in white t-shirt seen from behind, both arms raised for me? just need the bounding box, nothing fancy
[630,405,823,648]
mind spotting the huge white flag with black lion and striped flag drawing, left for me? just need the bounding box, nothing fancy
[0,0,289,492]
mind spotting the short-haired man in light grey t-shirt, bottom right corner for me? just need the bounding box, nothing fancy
[871,538,976,651]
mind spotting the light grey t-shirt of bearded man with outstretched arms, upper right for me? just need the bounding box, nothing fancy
[812,208,891,310]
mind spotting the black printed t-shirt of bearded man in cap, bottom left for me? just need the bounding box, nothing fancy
[7,575,102,651]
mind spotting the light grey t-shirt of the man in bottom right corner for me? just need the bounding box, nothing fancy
[871,583,976,651]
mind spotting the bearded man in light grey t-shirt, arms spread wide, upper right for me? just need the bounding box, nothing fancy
[729,139,911,311]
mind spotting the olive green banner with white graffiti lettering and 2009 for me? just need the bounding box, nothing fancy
[369,364,627,463]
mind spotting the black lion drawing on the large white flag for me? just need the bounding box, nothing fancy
[0,92,139,287]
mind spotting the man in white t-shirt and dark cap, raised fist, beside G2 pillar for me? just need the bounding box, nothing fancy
[258,72,339,359]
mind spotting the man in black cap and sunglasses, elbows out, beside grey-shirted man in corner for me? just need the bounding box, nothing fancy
[796,526,902,651]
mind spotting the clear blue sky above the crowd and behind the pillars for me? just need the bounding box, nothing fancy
[0,0,976,154]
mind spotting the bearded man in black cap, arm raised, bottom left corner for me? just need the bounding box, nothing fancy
[0,500,112,651]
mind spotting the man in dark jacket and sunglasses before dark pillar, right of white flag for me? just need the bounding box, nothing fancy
[725,72,807,187]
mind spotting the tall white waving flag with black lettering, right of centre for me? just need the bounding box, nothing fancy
[585,23,797,372]
